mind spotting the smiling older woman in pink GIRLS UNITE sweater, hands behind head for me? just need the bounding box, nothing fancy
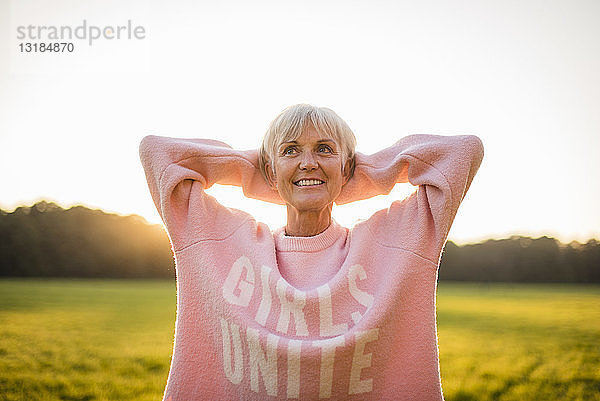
[140,105,483,401]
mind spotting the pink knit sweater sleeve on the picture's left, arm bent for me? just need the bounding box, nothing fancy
[139,135,281,251]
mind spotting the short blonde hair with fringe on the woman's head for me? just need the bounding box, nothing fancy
[258,104,356,181]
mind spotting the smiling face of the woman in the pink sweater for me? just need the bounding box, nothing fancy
[266,124,349,213]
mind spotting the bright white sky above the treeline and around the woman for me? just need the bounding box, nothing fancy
[0,0,600,243]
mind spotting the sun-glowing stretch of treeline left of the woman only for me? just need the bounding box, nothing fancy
[0,201,175,278]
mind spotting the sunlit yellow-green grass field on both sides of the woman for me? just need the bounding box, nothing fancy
[0,280,600,401]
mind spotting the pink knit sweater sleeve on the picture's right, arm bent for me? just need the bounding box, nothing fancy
[336,135,483,265]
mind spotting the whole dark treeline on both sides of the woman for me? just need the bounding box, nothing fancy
[0,201,600,283]
